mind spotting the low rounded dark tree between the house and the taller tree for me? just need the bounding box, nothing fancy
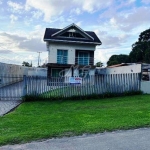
[107,54,130,66]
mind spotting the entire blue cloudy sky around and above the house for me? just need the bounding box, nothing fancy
[0,0,150,66]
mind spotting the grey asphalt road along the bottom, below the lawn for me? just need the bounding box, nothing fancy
[0,128,150,150]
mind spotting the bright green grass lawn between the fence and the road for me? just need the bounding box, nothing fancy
[0,95,150,145]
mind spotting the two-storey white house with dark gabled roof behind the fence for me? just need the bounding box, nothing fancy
[44,23,102,77]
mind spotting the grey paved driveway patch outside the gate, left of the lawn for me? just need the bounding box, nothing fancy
[0,101,21,116]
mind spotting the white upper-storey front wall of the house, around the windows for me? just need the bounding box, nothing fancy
[48,43,95,64]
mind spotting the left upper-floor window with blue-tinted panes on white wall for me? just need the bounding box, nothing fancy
[57,49,68,64]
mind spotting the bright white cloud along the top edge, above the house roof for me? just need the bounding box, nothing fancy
[25,0,113,22]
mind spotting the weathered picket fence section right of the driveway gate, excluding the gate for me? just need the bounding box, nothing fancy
[25,73,140,98]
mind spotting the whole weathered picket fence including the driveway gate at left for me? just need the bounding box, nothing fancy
[0,73,141,100]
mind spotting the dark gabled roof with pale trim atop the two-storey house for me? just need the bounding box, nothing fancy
[44,23,102,45]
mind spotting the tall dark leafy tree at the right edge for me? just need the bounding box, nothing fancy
[129,29,150,63]
